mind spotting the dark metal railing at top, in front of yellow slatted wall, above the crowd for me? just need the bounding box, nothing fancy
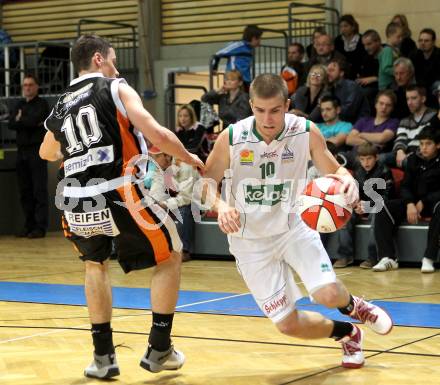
[288,2,339,47]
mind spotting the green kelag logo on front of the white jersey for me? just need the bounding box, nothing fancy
[244,182,291,206]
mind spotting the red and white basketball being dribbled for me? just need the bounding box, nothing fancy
[298,177,352,233]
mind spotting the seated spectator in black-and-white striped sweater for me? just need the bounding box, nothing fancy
[388,86,436,168]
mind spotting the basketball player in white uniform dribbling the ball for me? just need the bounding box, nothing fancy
[204,74,393,368]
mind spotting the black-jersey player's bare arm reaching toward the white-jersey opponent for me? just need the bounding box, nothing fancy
[119,83,204,169]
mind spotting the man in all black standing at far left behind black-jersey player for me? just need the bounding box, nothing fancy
[9,74,49,238]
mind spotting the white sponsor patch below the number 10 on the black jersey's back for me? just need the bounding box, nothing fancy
[64,145,114,177]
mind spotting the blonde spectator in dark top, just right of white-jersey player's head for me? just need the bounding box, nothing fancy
[290,64,327,122]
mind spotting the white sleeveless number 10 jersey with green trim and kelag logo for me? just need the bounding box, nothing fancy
[225,114,310,238]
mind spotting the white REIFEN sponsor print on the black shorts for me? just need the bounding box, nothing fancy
[64,208,119,238]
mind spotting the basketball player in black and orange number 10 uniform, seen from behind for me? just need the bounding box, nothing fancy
[40,35,204,378]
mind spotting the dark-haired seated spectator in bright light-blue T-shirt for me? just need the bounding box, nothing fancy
[317,95,352,149]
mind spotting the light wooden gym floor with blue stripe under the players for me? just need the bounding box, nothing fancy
[0,233,440,385]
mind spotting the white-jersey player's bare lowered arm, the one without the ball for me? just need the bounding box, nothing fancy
[202,130,240,234]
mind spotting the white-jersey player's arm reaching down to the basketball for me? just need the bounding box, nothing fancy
[309,123,359,204]
